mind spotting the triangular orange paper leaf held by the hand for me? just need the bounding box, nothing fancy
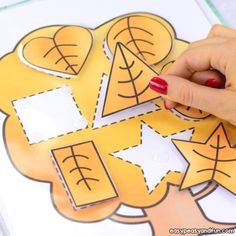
[102,43,160,117]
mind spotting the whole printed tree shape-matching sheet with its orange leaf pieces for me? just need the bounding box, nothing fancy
[0,0,236,236]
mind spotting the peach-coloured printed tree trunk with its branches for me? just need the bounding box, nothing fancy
[111,183,235,236]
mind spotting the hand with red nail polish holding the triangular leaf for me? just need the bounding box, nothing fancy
[150,25,236,125]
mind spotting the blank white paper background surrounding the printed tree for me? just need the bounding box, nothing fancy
[0,0,236,236]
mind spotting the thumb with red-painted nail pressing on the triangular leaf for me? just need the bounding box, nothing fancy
[150,75,228,116]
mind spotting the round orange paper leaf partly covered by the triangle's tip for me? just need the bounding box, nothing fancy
[106,15,172,65]
